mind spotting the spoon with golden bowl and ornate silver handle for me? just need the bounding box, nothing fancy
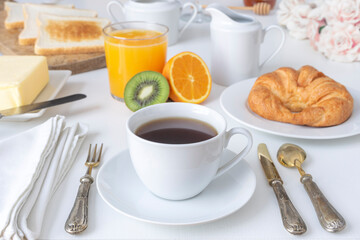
[277,143,346,232]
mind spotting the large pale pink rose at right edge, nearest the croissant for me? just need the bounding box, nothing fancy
[317,22,360,62]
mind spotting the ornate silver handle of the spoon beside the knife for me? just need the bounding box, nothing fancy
[300,174,346,232]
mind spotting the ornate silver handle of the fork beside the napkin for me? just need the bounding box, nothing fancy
[65,175,94,234]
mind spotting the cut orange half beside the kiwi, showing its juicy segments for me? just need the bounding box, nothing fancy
[163,52,211,103]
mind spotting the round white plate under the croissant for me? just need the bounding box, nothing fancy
[220,78,360,139]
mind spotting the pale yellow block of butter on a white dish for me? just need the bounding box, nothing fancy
[0,56,49,110]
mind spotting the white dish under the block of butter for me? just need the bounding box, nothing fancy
[1,70,71,122]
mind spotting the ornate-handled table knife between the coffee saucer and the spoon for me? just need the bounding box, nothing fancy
[258,143,307,235]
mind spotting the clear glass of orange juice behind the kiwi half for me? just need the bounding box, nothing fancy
[103,22,169,101]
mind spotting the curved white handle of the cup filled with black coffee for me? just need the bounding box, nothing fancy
[214,127,253,179]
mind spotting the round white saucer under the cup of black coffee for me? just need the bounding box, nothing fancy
[96,150,256,225]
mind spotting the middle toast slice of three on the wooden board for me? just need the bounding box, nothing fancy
[19,3,97,45]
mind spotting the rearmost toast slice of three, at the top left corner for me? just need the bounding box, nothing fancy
[4,2,74,29]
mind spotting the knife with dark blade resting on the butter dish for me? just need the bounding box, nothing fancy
[0,94,86,119]
